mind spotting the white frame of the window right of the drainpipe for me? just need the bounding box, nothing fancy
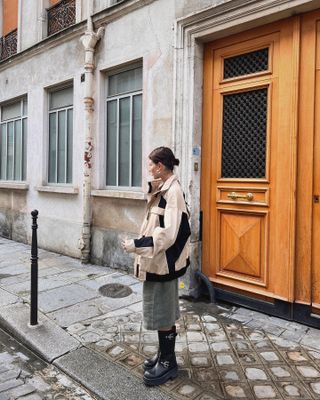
[103,62,143,192]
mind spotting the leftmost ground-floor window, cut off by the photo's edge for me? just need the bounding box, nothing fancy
[0,98,27,181]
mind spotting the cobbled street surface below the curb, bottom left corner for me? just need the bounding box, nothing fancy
[0,329,94,400]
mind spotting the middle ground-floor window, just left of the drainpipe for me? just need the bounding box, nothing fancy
[48,87,73,183]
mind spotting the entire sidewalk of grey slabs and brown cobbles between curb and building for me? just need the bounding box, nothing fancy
[0,239,320,400]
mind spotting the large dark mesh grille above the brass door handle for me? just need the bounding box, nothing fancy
[221,88,268,178]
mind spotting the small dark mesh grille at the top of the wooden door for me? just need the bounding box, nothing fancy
[223,48,269,79]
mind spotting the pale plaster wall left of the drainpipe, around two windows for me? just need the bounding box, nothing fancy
[0,31,84,257]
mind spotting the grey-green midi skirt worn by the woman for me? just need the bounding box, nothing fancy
[143,279,180,330]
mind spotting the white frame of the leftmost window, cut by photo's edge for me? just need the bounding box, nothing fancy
[0,96,28,182]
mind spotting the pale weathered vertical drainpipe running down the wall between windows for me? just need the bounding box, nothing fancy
[79,11,104,264]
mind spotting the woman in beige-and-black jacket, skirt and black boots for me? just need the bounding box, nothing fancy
[122,147,190,385]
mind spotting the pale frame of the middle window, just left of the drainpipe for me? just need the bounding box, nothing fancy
[46,82,74,187]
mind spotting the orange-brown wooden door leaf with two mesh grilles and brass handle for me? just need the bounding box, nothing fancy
[201,18,299,301]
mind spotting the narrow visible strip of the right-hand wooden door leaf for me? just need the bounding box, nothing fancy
[295,10,320,326]
